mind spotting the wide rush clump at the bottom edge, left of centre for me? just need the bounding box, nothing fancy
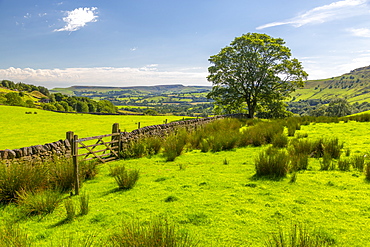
[110,219,198,247]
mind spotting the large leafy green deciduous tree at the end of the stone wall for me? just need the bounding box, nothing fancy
[207,33,308,118]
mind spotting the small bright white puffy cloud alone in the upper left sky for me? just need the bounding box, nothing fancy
[54,7,98,32]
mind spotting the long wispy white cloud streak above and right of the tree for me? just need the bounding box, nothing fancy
[256,0,369,30]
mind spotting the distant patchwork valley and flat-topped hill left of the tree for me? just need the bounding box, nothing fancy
[50,84,213,116]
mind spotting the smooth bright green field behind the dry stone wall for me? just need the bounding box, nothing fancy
[0,105,182,149]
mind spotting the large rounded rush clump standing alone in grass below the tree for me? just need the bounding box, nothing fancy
[255,149,289,178]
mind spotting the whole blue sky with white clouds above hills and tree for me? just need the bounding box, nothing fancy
[0,0,370,88]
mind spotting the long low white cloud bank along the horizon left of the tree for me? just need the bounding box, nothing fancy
[0,64,210,88]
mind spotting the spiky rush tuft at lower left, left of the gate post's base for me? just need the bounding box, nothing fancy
[18,190,62,216]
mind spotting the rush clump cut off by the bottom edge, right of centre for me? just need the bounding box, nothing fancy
[265,224,336,247]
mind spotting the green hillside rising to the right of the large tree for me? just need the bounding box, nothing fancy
[292,66,370,103]
